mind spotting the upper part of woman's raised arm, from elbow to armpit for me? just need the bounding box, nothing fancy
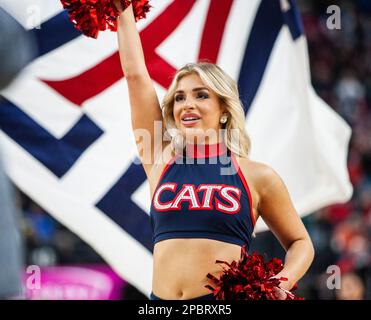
[126,73,170,175]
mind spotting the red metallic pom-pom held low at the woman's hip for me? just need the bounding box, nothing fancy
[205,245,303,300]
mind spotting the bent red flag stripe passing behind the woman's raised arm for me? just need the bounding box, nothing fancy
[41,0,196,106]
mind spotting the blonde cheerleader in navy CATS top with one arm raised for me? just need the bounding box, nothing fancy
[115,1,314,300]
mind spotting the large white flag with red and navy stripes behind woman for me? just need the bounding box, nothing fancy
[0,0,352,295]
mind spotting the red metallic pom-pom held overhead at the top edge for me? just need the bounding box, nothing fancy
[61,0,151,38]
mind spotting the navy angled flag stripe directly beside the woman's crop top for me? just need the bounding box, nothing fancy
[96,163,153,253]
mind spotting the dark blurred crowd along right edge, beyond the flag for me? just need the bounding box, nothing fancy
[290,0,371,299]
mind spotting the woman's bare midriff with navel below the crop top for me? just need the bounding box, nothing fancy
[152,238,241,300]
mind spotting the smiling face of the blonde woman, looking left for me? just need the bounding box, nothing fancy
[173,74,227,143]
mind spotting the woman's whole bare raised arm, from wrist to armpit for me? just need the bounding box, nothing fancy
[115,0,163,176]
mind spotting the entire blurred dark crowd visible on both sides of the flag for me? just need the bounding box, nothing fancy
[5,0,371,300]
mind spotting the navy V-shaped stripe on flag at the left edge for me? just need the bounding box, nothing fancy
[0,99,103,178]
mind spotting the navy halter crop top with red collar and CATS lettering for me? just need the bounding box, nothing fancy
[150,143,255,248]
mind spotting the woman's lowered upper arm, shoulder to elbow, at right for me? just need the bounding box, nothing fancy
[258,166,309,250]
